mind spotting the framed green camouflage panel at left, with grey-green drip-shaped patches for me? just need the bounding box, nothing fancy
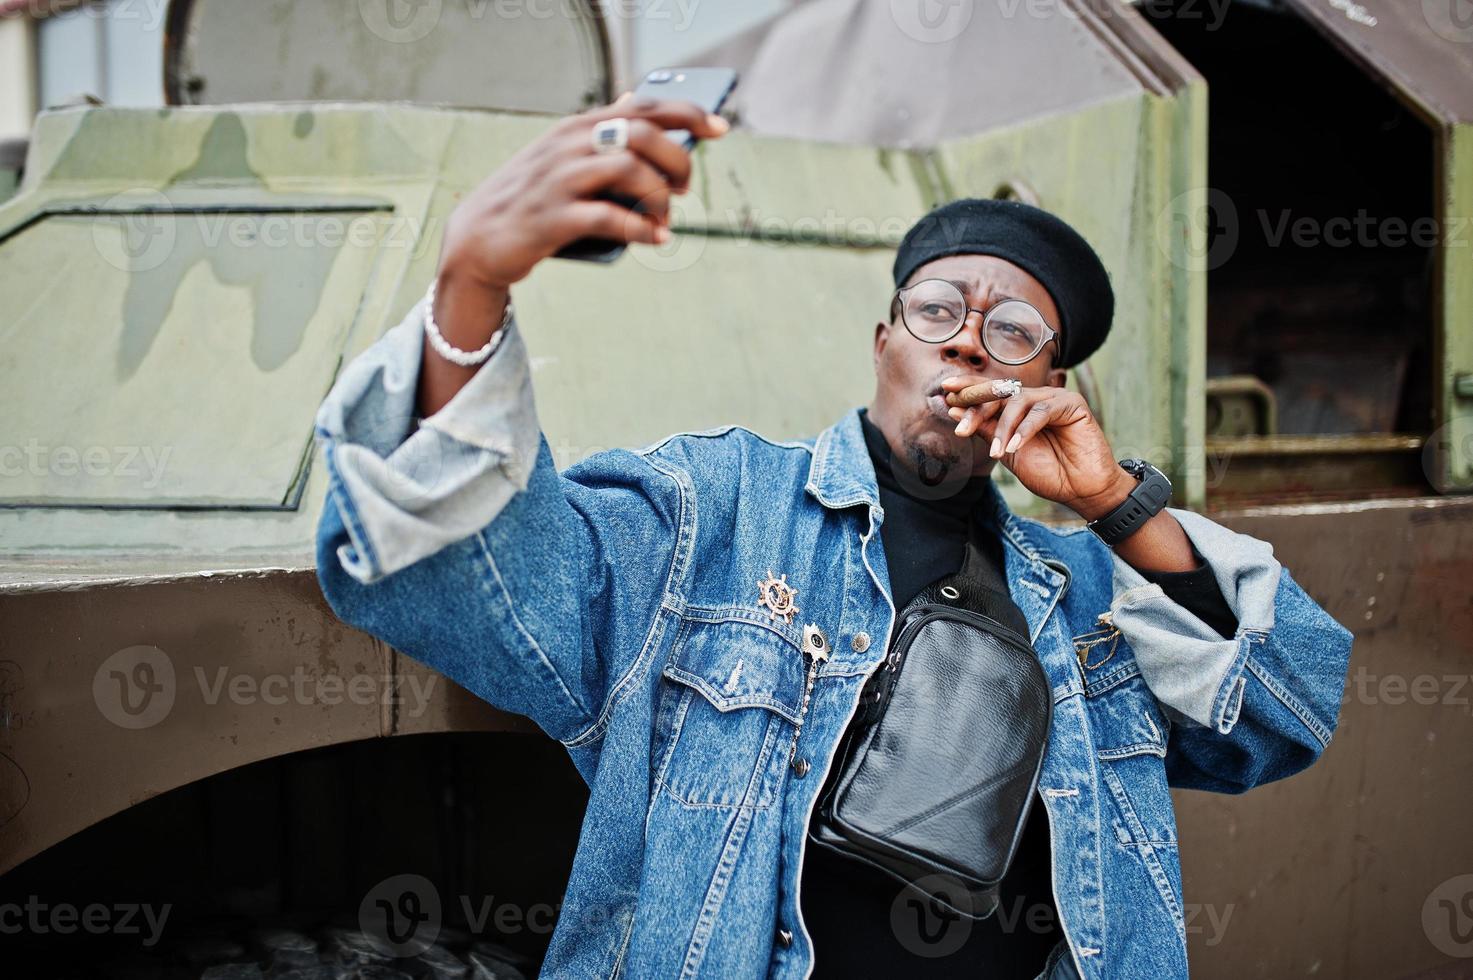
[0,211,384,507]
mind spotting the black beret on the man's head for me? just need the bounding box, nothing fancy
[894,197,1115,367]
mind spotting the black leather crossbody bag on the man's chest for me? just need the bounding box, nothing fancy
[809,520,1053,920]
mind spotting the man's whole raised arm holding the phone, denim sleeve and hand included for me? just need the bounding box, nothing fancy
[315,102,719,743]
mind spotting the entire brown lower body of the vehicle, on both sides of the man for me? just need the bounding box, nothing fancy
[0,498,1473,980]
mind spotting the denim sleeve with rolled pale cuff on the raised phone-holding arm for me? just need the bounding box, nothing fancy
[315,301,683,744]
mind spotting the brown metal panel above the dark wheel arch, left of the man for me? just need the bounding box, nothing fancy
[0,572,539,874]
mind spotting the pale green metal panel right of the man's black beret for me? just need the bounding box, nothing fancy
[937,83,1206,510]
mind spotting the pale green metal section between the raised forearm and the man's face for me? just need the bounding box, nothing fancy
[517,236,893,453]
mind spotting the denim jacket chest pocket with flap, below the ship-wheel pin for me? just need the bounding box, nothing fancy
[654,610,806,809]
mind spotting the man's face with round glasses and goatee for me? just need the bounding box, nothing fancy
[869,255,1065,485]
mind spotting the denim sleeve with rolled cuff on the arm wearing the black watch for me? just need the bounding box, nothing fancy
[1111,508,1352,791]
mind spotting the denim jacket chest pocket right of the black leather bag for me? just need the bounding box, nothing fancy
[1084,662,1177,846]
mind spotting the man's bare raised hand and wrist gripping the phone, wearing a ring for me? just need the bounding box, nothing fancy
[418,94,729,416]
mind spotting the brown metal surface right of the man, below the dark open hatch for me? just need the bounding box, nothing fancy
[1175,498,1473,980]
